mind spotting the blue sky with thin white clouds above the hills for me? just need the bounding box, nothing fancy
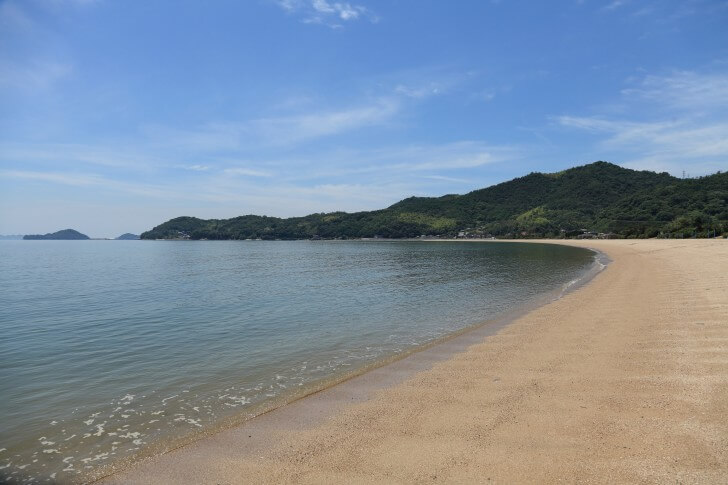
[0,0,728,237]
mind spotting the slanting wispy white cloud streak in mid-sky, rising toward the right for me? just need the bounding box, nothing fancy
[141,63,484,153]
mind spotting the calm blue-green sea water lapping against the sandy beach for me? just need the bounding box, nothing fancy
[0,241,594,483]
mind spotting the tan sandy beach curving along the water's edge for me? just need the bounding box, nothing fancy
[104,240,728,484]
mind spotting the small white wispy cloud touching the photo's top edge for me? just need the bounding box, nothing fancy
[274,0,379,28]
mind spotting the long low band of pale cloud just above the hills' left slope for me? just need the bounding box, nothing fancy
[0,141,513,216]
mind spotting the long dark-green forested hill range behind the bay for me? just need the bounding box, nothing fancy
[141,162,728,239]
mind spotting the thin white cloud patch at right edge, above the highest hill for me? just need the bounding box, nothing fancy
[556,71,728,174]
